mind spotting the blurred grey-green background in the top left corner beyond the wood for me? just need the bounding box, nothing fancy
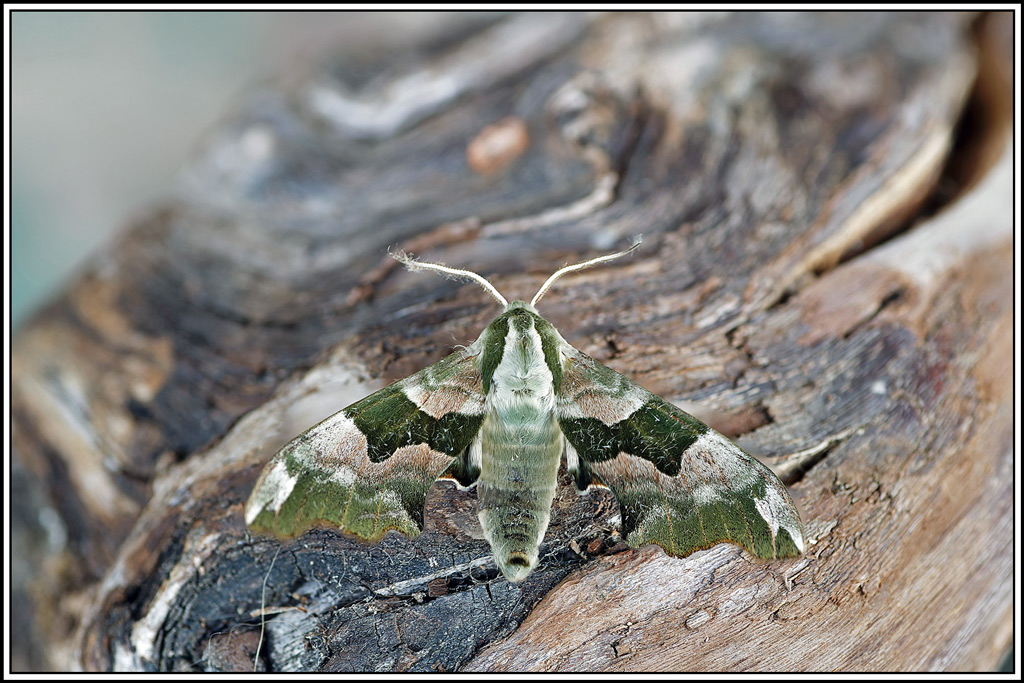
[10,11,471,330]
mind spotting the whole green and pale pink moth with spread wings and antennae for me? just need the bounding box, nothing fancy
[246,240,804,582]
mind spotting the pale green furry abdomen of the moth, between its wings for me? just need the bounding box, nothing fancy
[477,407,562,581]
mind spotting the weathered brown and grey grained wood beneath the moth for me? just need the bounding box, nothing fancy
[12,13,1014,671]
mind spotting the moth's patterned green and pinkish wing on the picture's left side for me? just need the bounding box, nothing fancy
[246,345,483,541]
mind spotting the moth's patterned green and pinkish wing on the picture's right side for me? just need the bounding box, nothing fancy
[557,344,804,558]
